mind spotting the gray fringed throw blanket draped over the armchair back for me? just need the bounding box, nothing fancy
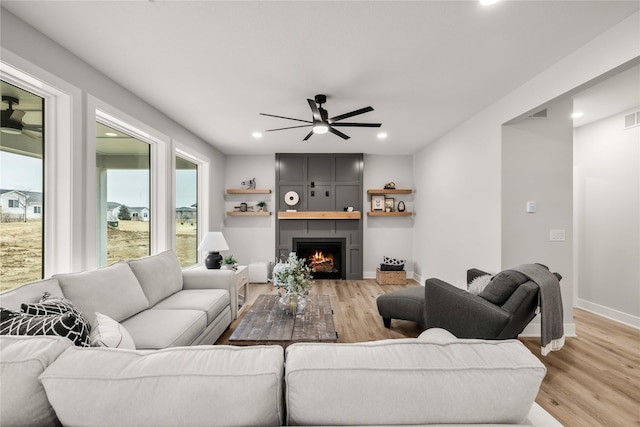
[511,264,564,356]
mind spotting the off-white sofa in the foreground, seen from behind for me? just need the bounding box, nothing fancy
[0,329,561,427]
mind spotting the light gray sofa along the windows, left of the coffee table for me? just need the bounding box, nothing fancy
[0,250,237,349]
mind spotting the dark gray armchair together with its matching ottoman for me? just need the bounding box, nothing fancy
[377,268,561,339]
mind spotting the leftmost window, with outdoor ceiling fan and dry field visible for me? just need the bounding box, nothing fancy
[0,81,44,291]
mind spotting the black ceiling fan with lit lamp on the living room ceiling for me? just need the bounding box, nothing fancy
[260,95,382,141]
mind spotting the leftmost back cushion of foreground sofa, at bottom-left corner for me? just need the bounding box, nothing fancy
[0,336,73,426]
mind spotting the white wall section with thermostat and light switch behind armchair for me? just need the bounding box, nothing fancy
[501,97,575,336]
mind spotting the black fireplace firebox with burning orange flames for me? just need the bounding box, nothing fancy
[293,238,346,279]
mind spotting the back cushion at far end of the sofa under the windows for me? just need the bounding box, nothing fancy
[128,250,182,306]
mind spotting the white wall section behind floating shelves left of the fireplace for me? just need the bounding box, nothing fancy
[223,155,277,265]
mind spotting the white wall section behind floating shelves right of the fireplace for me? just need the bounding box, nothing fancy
[362,154,415,278]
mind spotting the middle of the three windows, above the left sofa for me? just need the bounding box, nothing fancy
[96,122,151,266]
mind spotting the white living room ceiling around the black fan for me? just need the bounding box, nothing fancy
[2,0,640,154]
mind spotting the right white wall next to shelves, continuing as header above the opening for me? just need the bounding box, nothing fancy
[413,13,640,334]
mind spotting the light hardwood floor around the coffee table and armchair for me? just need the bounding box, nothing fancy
[216,280,640,427]
